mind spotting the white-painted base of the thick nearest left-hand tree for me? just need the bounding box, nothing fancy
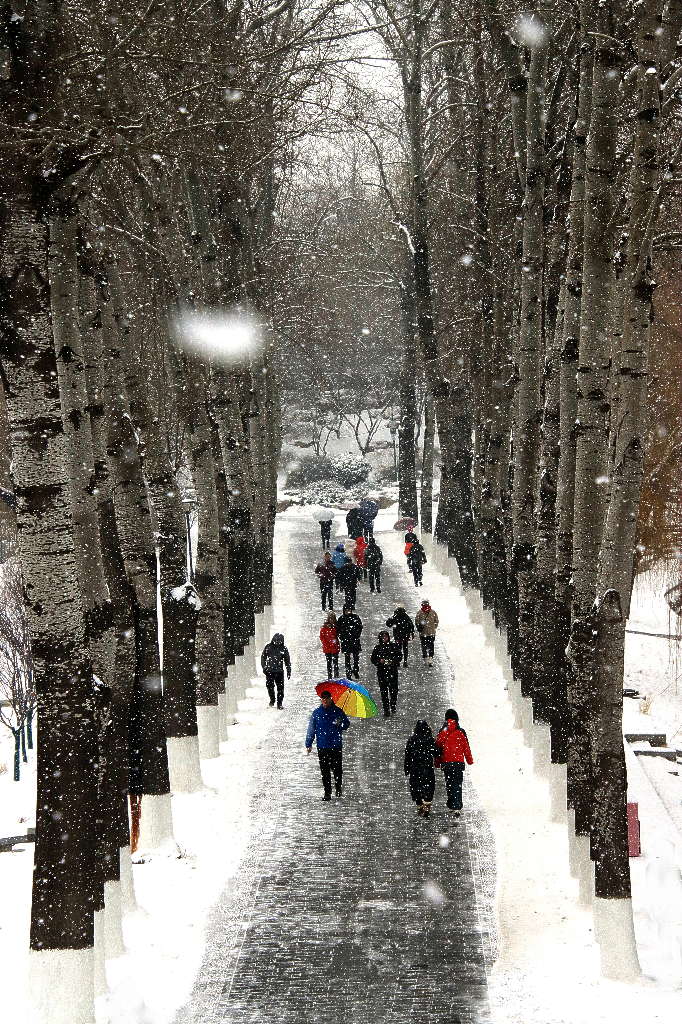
[29,946,95,1024]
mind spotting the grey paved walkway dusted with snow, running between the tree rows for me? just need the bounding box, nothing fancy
[177,519,495,1024]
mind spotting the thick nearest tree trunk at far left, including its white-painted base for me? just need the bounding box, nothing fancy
[0,190,97,1024]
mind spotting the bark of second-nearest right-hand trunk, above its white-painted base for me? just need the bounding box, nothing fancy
[567,4,622,834]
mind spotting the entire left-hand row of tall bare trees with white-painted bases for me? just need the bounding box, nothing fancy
[0,0,350,1022]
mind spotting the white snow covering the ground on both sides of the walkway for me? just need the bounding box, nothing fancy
[0,507,682,1024]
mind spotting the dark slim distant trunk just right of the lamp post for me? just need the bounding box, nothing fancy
[397,274,419,520]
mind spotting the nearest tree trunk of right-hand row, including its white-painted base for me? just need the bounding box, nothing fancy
[592,0,664,977]
